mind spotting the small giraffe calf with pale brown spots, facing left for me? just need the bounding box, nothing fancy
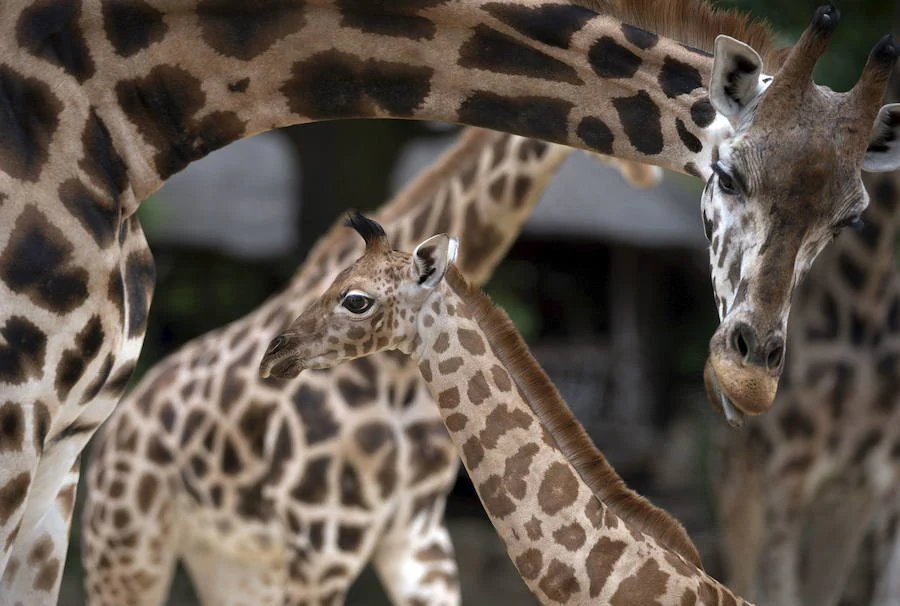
[260,214,746,606]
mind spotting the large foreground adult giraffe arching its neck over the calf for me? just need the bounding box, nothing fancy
[0,0,897,604]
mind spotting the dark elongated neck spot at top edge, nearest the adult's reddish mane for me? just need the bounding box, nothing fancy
[482,2,597,48]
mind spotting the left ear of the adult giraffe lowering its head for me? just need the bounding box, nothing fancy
[709,35,766,128]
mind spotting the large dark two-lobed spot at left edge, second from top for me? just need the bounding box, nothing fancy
[0,206,88,313]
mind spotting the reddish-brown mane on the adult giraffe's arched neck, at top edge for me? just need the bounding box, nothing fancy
[574,0,787,73]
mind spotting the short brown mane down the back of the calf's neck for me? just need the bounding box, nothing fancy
[445,265,703,570]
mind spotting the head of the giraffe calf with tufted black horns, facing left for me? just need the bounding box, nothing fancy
[260,213,459,378]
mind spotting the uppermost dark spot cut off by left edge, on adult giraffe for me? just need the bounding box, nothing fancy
[0,65,63,181]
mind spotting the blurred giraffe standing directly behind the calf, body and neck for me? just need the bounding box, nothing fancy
[83,129,592,605]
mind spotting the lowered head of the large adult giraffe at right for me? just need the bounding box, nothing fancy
[701,6,900,425]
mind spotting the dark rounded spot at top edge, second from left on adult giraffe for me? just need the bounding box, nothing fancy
[101,0,168,57]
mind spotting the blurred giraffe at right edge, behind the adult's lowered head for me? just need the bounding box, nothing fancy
[716,163,900,606]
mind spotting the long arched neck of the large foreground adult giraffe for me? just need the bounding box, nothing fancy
[0,0,740,200]
